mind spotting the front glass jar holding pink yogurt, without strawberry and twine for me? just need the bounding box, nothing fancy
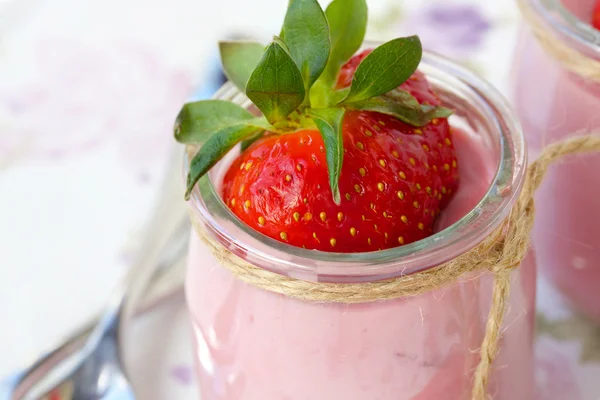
[186,54,535,400]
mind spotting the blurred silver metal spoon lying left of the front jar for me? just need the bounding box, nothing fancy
[2,148,189,400]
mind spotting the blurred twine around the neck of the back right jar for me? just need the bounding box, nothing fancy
[517,0,600,82]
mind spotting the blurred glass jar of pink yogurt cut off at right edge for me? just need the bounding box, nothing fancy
[512,0,600,320]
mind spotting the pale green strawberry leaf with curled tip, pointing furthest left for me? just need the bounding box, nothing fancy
[174,100,269,144]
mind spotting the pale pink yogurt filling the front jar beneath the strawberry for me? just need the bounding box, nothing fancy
[186,131,535,400]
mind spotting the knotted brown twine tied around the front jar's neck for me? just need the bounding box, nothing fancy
[192,131,600,400]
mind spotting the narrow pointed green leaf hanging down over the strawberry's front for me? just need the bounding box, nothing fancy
[307,108,345,204]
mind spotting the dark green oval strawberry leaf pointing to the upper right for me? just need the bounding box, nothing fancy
[344,36,423,103]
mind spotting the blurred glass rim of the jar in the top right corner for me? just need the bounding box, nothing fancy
[521,0,600,59]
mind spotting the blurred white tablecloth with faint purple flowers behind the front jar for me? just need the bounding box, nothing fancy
[0,0,598,399]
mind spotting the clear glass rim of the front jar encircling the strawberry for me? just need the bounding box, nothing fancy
[184,52,527,282]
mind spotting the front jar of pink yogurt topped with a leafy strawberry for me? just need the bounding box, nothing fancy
[175,0,535,400]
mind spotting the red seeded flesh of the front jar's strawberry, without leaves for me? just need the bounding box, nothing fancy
[223,53,458,252]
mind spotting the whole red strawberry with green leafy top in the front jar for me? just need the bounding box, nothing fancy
[175,0,459,252]
